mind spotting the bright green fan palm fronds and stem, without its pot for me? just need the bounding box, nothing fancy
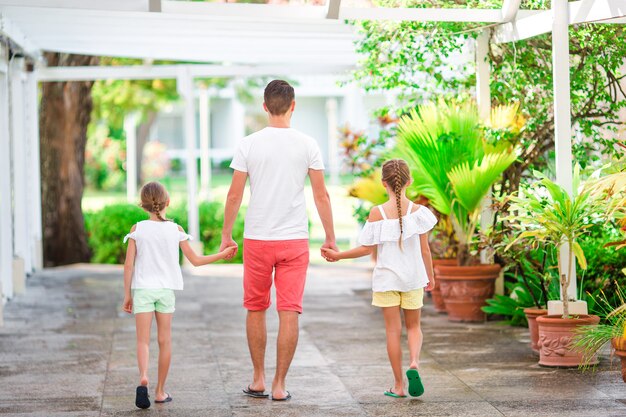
[397,101,517,265]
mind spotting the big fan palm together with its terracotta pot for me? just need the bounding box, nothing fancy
[396,101,516,322]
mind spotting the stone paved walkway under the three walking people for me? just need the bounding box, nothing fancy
[0,265,626,417]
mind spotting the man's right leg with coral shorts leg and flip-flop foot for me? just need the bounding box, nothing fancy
[272,239,309,400]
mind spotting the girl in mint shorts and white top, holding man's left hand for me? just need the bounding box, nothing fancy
[122,182,237,408]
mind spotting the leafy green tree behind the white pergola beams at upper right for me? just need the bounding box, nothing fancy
[354,0,626,195]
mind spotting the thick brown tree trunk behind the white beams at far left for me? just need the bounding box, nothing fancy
[39,52,98,266]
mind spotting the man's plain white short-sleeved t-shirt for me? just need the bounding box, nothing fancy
[230,127,324,240]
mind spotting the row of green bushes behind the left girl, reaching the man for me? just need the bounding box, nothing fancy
[85,202,244,264]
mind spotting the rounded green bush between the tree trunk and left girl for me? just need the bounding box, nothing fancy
[85,204,148,264]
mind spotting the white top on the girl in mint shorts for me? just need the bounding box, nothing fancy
[124,220,191,290]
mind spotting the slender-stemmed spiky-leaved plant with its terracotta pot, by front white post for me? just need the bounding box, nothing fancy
[508,167,602,367]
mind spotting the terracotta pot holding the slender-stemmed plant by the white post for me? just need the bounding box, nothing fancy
[537,315,600,367]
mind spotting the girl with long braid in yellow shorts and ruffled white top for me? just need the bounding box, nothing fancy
[322,159,437,398]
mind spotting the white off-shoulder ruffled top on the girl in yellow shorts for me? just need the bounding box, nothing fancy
[359,202,437,292]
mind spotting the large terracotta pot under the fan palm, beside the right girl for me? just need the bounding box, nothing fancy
[435,265,500,322]
